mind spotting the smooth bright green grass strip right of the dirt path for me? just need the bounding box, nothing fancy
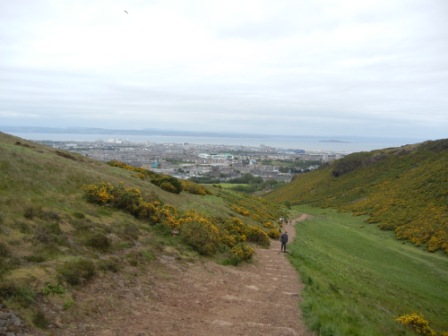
[289,206,448,336]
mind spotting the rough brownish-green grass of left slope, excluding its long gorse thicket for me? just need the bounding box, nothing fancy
[0,133,284,328]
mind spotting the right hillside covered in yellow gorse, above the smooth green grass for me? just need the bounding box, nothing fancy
[265,139,448,253]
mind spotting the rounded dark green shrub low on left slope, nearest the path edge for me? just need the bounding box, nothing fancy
[57,259,96,286]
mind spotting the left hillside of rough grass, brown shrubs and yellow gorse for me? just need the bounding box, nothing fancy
[0,133,286,334]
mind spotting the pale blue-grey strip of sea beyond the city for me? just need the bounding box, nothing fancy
[5,130,427,154]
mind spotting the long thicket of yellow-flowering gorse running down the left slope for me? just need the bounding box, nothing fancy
[83,182,280,264]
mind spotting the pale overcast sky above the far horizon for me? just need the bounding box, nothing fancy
[0,0,448,139]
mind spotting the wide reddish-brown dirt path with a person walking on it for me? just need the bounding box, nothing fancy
[48,218,311,336]
